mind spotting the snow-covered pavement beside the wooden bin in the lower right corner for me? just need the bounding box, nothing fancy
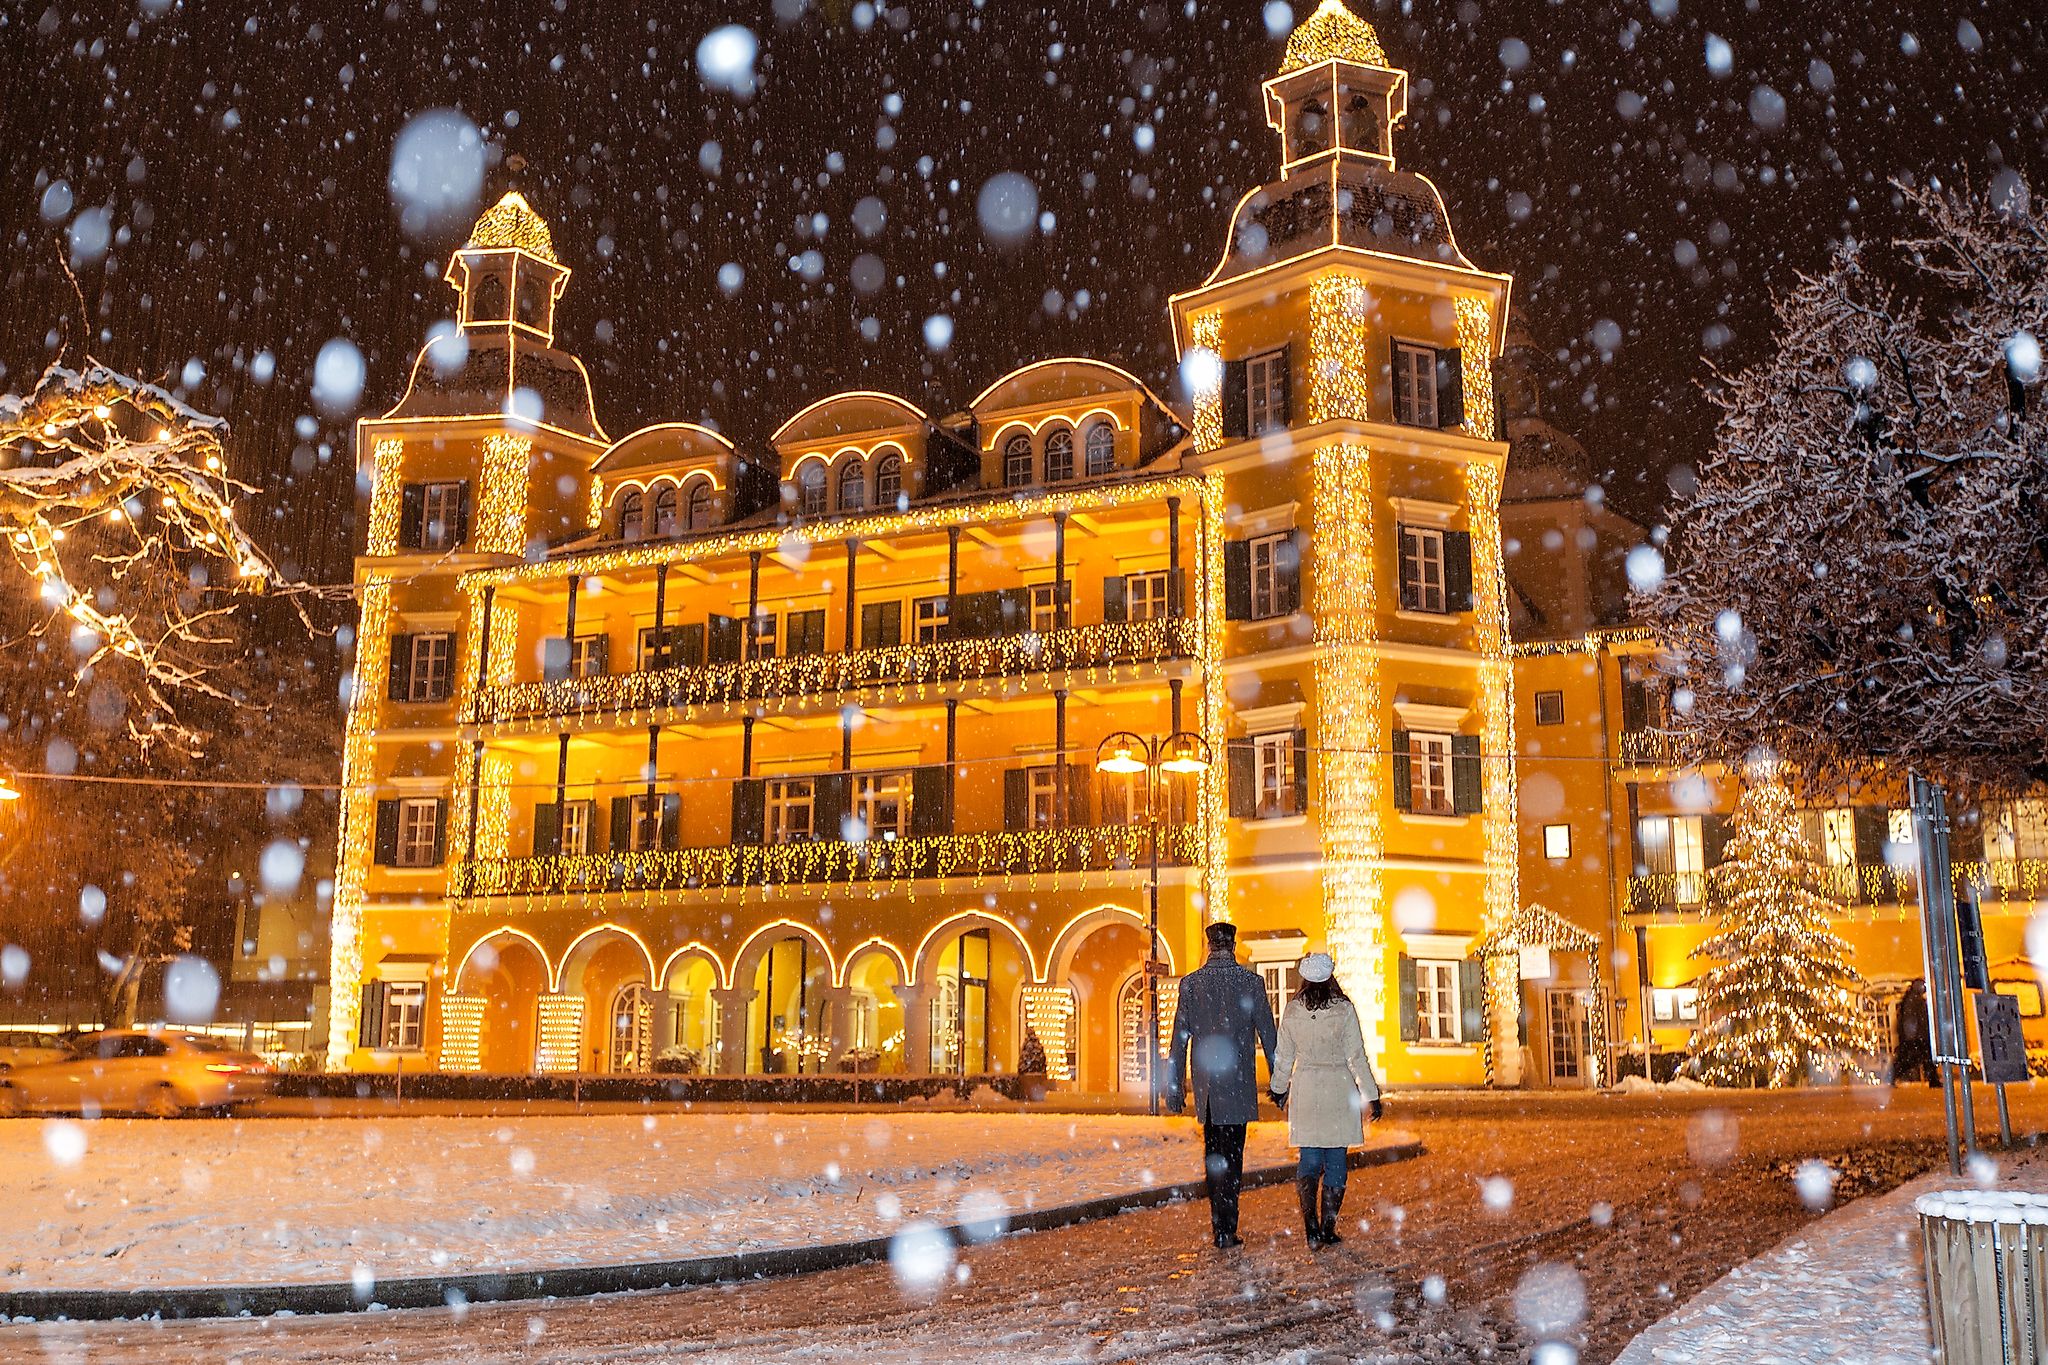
[1616,1156,2048,1365]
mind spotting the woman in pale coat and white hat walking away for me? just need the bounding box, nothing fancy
[1272,954,1380,1246]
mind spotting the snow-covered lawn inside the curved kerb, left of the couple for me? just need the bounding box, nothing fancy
[0,1111,1327,1289]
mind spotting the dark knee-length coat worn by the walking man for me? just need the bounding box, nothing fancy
[1167,950,1274,1124]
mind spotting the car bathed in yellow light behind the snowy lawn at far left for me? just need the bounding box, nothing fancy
[0,1029,272,1119]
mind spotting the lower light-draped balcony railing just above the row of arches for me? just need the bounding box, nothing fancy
[449,825,1200,898]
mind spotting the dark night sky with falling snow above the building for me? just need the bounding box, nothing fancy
[0,0,2048,581]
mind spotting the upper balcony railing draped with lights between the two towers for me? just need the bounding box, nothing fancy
[465,618,1200,724]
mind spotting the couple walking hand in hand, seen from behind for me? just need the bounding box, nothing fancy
[1167,923,1380,1248]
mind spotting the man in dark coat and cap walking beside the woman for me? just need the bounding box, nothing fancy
[1165,921,1274,1250]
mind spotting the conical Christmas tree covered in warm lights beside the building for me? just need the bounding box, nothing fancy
[1690,765,1874,1087]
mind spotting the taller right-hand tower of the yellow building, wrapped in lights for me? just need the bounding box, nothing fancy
[1171,0,1520,1085]
